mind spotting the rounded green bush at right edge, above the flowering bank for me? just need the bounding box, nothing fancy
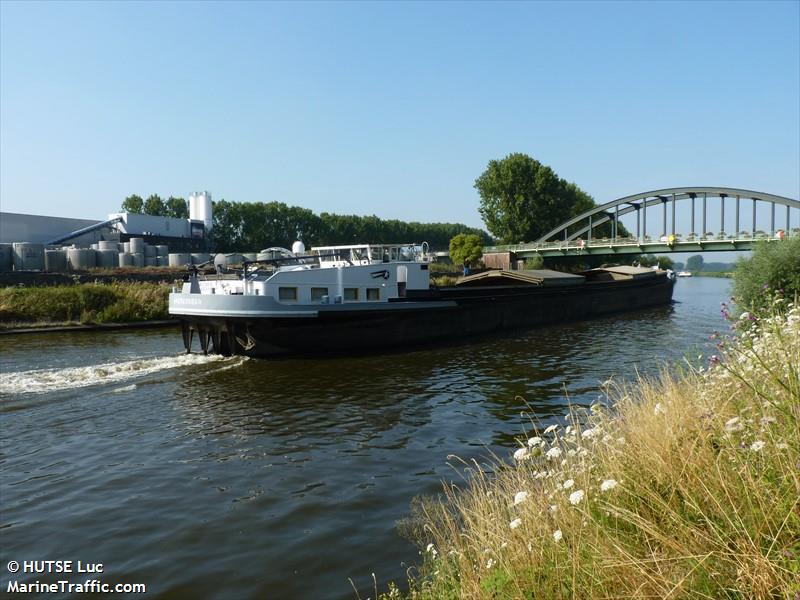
[733,237,800,310]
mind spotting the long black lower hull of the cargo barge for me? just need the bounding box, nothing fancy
[178,276,674,357]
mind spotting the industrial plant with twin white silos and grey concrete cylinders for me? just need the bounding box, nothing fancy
[0,192,213,271]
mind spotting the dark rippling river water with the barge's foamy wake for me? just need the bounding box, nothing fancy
[0,278,728,598]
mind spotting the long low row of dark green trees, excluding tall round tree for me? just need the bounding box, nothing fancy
[122,195,492,252]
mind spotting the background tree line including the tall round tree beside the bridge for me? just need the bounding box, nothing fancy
[122,153,629,252]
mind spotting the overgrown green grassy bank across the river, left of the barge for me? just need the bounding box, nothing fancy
[0,283,170,329]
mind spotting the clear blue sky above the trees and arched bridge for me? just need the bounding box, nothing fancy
[0,1,800,236]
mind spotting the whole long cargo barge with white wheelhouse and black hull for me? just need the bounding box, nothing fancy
[169,244,674,356]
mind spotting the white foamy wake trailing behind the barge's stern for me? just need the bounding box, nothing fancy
[0,354,243,394]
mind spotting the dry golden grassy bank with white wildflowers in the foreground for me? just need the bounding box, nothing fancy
[396,303,800,599]
